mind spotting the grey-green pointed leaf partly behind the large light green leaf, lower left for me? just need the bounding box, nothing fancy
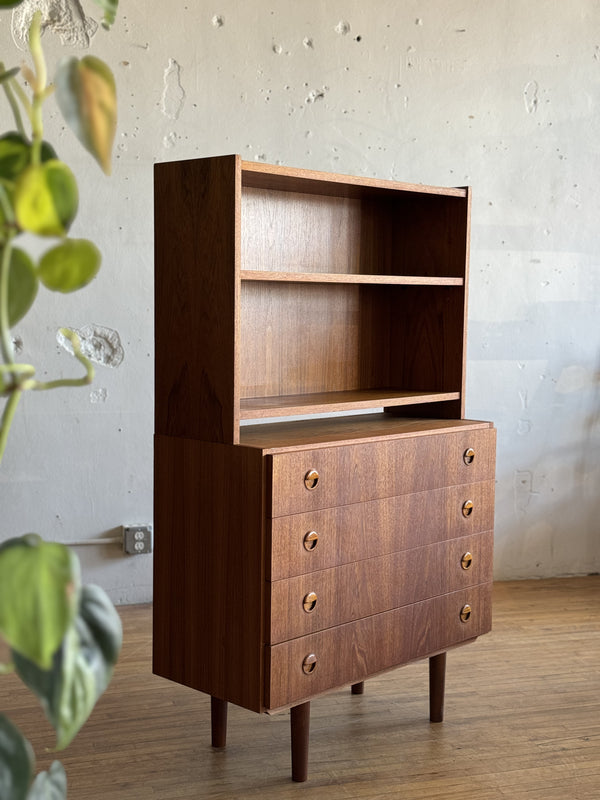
[13,586,122,750]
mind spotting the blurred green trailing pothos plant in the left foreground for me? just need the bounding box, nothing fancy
[0,0,122,800]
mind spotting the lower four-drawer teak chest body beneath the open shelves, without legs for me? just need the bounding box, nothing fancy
[154,419,495,774]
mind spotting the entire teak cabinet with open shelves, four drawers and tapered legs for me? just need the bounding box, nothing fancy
[154,156,495,780]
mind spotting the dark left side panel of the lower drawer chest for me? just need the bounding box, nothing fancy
[153,436,264,711]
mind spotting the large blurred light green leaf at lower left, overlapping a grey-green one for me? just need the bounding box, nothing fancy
[0,534,80,669]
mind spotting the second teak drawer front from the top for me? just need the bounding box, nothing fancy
[267,481,494,581]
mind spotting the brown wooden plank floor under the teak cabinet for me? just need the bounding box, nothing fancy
[0,577,600,800]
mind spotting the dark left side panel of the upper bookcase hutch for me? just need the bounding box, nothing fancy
[154,156,241,443]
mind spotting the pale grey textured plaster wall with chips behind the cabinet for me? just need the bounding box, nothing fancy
[0,0,600,602]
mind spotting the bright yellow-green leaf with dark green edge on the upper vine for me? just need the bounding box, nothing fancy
[14,159,79,236]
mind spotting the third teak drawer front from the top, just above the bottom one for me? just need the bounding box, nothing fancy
[267,531,494,644]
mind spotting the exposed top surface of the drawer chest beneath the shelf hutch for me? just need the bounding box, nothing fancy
[240,413,493,453]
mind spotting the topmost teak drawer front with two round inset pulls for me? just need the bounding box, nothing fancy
[270,428,496,517]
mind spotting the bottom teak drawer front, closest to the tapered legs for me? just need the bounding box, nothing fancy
[265,583,492,710]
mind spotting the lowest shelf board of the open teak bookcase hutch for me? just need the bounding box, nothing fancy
[240,389,460,419]
